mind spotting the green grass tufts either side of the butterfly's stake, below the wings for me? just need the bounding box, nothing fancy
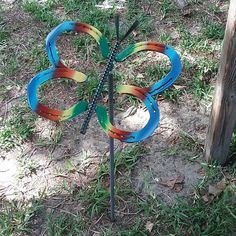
[79,145,145,217]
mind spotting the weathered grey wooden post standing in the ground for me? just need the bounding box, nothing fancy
[204,0,236,164]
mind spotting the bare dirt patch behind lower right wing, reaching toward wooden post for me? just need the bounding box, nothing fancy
[120,101,208,205]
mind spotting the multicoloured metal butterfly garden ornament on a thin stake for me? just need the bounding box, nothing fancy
[27,16,182,220]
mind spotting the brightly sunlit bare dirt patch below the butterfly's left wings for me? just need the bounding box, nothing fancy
[0,112,112,200]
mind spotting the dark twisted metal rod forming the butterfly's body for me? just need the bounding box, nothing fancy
[80,40,120,134]
